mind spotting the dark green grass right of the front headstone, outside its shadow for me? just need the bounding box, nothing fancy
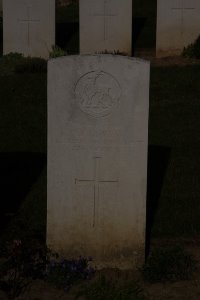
[149,66,200,236]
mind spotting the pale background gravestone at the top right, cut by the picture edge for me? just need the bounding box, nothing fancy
[156,0,200,57]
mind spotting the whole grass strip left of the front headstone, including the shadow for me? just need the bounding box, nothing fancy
[0,56,47,243]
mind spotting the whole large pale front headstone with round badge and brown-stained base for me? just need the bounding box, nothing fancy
[47,55,149,269]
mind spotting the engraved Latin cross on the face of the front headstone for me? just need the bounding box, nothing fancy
[75,157,118,227]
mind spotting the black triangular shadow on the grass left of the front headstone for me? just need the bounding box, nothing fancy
[0,152,46,234]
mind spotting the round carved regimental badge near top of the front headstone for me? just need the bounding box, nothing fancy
[75,71,121,117]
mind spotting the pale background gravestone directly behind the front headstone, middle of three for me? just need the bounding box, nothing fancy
[79,0,132,55]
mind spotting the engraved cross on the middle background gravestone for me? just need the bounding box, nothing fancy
[93,0,117,41]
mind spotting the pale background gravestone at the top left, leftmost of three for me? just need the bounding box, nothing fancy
[3,0,55,58]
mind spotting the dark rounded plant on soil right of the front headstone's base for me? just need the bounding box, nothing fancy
[142,246,196,283]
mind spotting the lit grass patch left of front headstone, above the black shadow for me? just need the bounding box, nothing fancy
[0,69,47,153]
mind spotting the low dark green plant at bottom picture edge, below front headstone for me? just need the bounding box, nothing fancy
[77,275,144,300]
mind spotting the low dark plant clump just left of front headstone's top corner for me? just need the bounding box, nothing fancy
[15,57,47,74]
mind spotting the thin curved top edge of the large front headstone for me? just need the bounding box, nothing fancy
[48,54,151,65]
